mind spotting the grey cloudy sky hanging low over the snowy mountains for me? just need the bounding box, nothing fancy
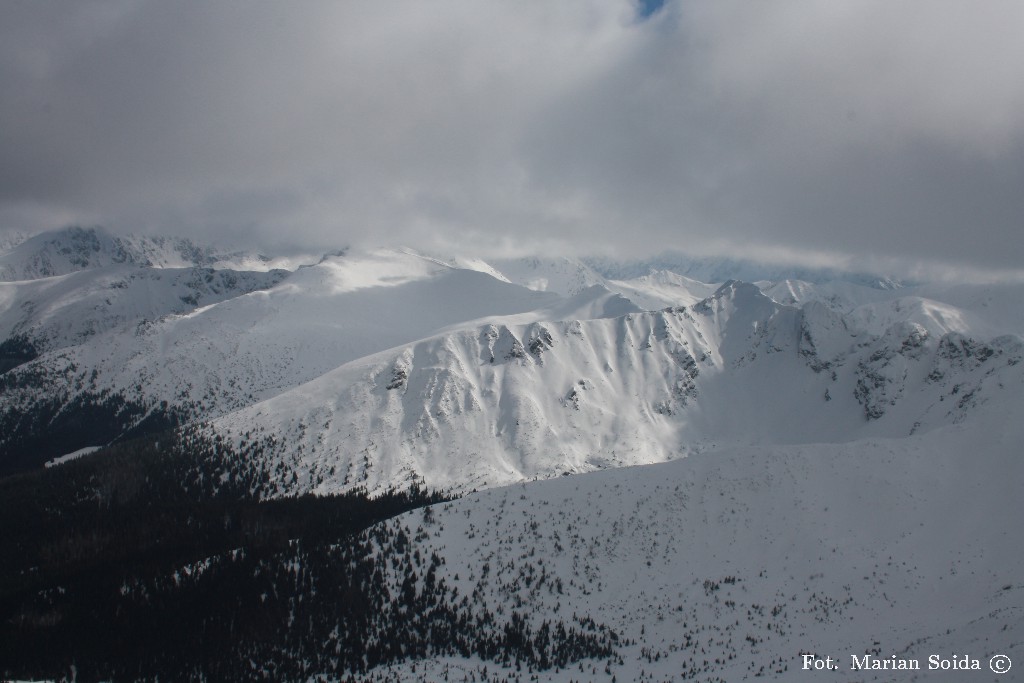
[0,0,1024,269]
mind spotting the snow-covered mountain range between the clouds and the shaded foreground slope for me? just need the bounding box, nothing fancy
[0,229,1024,496]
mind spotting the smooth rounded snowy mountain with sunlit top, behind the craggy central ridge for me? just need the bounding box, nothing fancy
[74,253,556,412]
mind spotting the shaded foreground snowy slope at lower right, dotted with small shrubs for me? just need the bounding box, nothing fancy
[356,403,1024,682]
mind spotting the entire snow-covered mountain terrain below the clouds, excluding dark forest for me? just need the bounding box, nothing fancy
[0,228,1024,681]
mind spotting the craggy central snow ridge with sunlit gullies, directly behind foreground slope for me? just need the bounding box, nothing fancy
[201,282,1024,493]
